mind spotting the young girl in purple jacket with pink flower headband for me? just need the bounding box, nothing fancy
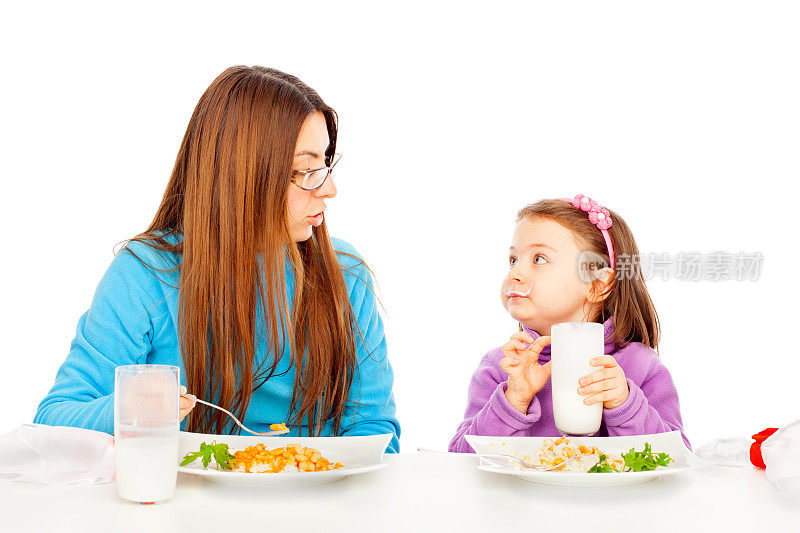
[450,195,689,452]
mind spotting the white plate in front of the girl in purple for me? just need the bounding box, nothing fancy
[466,431,709,487]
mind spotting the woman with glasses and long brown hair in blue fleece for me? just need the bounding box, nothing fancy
[35,66,400,452]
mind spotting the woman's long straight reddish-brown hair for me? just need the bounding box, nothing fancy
[122,66,357,435]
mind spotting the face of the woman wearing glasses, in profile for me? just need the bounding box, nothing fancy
[287,111,336,242]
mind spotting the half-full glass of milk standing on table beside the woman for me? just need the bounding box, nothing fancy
[114,365,180,503]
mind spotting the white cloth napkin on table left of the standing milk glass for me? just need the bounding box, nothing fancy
[0,424,114,485]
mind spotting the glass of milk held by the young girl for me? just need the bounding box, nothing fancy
[550,322,605,436]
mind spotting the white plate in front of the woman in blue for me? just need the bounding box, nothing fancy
[178,431,392,487]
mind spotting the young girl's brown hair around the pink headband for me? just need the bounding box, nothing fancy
[517,199,661,350]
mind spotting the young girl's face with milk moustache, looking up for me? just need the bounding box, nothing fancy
[501,217,593,335]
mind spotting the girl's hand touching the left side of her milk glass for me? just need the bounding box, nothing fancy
[500,331,550,414]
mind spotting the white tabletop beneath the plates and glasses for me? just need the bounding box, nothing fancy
[0,454,800,533]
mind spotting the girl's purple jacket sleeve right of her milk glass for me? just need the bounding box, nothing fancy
[603,359,691,450]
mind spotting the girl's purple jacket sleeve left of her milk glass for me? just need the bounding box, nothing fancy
[449,352,542,453]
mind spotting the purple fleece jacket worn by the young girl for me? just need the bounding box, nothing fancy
[450,318,691,452]
